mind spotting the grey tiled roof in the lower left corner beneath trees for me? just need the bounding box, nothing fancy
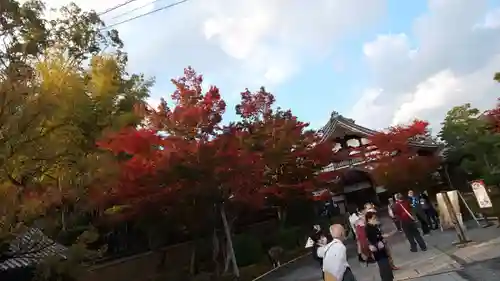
[0,228,67,270]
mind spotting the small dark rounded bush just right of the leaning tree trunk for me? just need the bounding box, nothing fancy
[233,234,264,266]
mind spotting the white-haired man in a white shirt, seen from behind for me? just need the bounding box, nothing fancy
[318,224,356,281]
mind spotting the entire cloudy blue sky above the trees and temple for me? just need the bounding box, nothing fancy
[34,0,500,130]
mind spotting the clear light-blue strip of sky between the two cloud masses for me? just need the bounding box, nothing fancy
[276,0,427,127]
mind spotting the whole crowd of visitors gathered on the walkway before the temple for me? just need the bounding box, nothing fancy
[311,190,440,281]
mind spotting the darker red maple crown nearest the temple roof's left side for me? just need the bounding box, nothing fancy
[236,88,333,208]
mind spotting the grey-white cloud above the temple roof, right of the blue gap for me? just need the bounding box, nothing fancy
[351,0,500,131]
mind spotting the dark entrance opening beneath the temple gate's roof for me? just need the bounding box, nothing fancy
[342,169,380,208]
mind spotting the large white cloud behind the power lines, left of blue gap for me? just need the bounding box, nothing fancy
[25,0,386,104]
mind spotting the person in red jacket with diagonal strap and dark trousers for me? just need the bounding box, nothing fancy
[394,193,427,252]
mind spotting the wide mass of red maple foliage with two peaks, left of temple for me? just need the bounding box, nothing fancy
[95,68,333,229]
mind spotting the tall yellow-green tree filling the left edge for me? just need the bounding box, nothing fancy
[0,0,153,277]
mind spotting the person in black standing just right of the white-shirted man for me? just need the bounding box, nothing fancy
[365,212,394,281]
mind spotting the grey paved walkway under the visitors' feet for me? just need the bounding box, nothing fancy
[259,217,500,281]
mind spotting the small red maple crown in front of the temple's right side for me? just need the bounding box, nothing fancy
[365,120,439,190]
